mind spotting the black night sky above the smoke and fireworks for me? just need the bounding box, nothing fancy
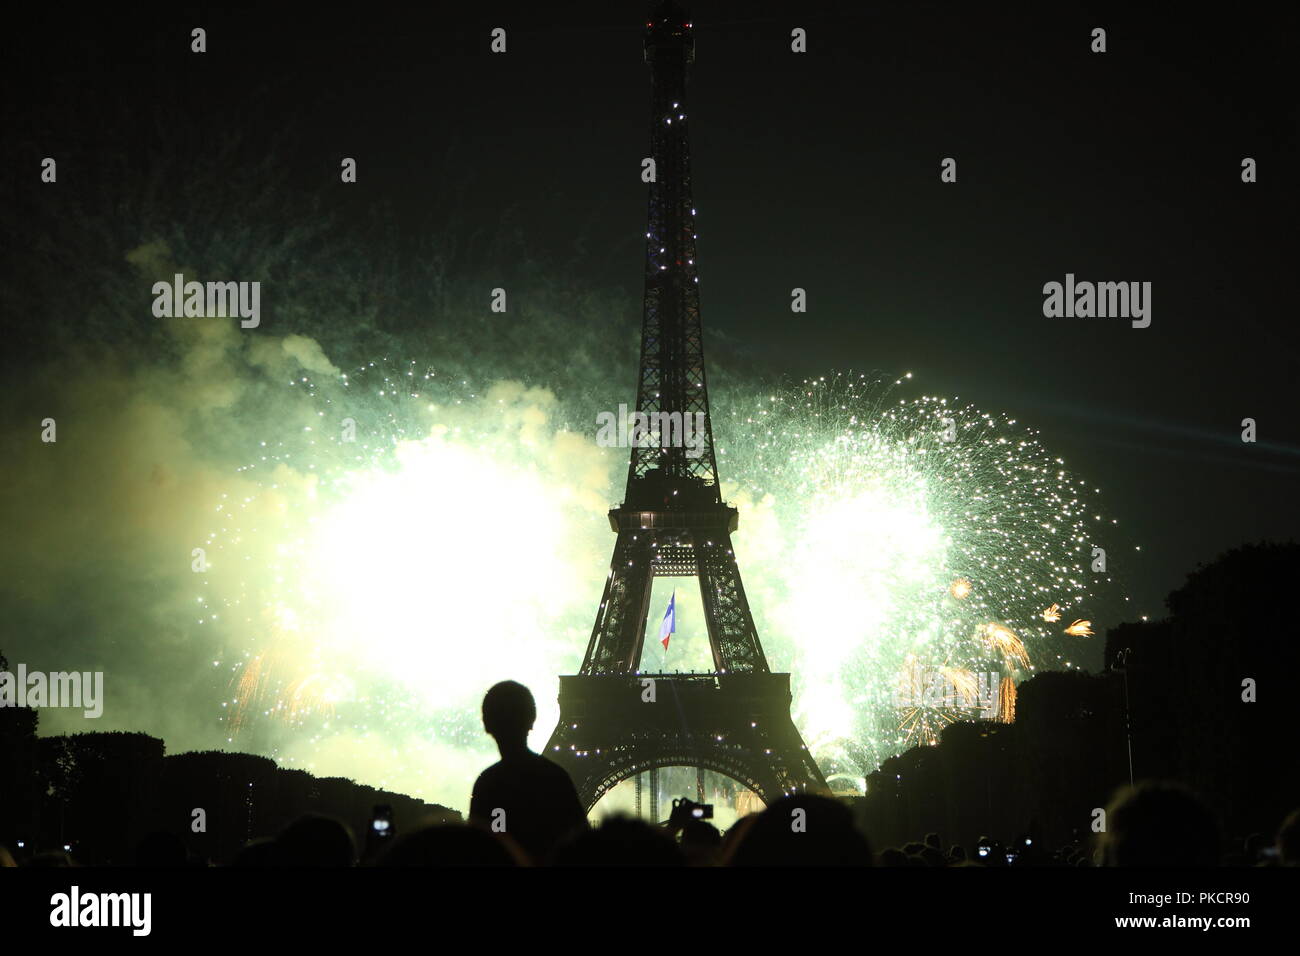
[4,3,1300,614]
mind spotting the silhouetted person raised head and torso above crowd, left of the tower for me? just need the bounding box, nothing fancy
[469,680,586,862]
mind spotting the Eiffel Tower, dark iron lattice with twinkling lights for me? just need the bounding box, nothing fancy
[545,0,828,809]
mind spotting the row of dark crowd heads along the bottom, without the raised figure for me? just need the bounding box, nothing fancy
[0,771,1300,868]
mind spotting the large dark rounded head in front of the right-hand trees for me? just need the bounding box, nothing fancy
[1102,780,1219,866]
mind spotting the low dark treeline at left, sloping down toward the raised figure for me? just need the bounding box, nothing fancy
[0,708,460,865]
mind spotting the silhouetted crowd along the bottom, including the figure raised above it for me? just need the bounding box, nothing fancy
[0,682,1300,869]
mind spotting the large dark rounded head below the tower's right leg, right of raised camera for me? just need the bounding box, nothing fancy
[728,793,868,866]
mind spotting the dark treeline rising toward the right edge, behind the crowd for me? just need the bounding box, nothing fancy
[857,544,1300,847]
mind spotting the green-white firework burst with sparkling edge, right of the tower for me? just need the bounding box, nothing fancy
[716,375,1109,771]
